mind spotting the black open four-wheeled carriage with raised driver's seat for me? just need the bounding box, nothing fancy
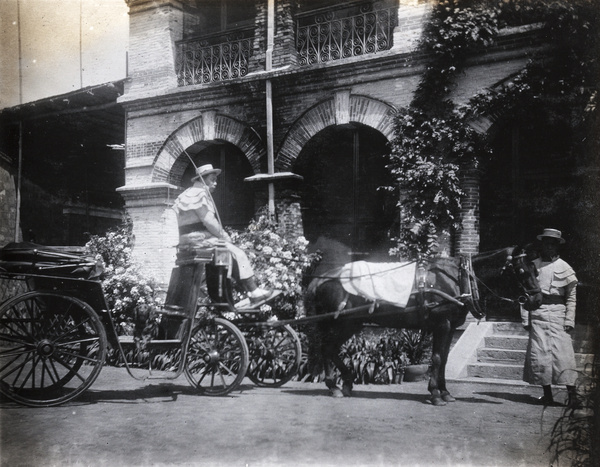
[0,244,302,406]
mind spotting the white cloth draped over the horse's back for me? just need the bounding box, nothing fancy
[338,261,417,308]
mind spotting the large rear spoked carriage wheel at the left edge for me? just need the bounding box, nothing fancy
[0,292,107,407]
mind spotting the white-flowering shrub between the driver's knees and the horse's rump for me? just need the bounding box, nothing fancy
[229,214,316,319]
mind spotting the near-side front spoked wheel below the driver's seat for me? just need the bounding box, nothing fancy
[185,318,248,396]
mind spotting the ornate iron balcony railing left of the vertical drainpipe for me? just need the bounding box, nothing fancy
[176,30,253,86]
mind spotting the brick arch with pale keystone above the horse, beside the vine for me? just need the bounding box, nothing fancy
[275,91,396,171]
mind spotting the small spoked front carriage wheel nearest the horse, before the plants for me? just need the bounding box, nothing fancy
[243,325,302,387]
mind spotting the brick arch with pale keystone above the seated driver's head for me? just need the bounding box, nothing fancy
[152,111,266,184]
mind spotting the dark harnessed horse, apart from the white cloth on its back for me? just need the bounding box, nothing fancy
[305,243,541,405]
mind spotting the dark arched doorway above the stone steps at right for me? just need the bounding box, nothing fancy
[480,113,579,321]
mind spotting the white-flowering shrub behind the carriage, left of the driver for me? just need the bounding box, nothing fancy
[85,222,158,335]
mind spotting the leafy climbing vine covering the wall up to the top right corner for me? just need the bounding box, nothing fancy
[384,0,600,258]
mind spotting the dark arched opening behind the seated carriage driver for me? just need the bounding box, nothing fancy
[180,141,255,230]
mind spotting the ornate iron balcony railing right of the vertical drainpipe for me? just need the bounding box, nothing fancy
[296,5,397,65]
